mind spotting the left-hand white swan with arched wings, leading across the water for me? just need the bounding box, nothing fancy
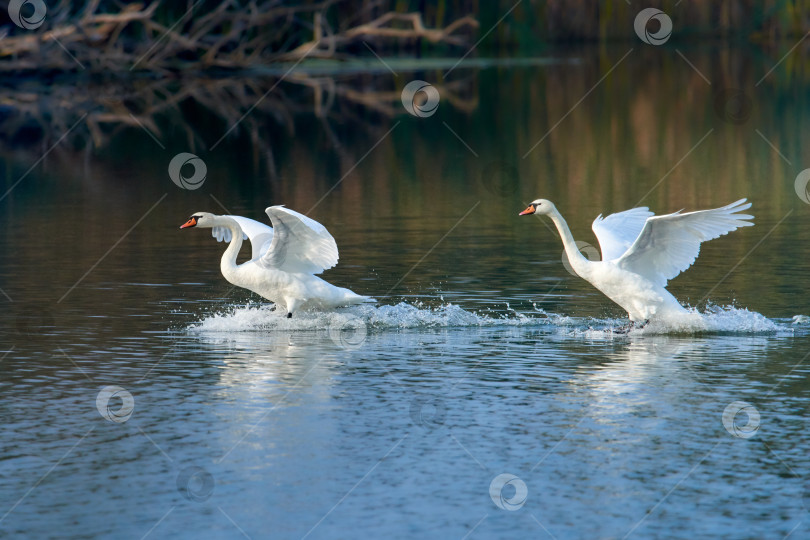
[180,206,374,317]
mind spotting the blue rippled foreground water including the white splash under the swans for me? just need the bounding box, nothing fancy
[0,304,810,538]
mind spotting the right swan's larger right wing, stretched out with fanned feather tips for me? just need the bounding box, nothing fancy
[616,199,754,287]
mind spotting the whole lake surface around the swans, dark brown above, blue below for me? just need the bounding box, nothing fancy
[0,44,810,539]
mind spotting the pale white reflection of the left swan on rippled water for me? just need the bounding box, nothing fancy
[194,331,344,462]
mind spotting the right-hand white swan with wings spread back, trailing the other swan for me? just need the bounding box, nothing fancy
[519,199,754,324]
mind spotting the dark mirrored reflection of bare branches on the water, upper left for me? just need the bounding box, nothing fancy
[0,73,478,173]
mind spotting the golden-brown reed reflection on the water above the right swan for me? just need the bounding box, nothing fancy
[518,47,810,211]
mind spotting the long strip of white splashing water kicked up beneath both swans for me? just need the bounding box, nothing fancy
[188,302,792,334]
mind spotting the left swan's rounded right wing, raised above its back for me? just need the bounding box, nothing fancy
[259,206,338,274]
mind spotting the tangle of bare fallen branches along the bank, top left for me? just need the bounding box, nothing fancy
[0,0,478,72]
